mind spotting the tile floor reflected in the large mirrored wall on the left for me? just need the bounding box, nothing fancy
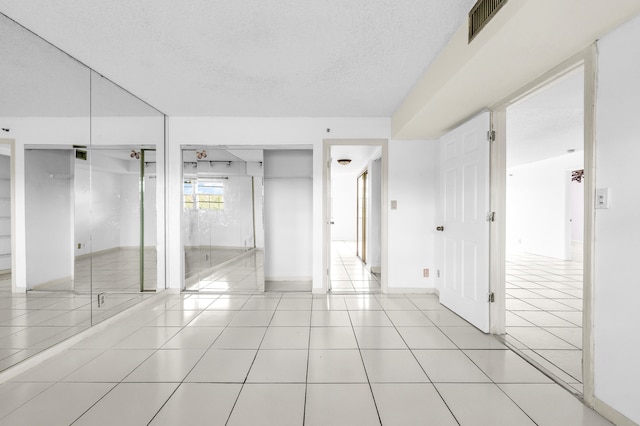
[0,250,156,371]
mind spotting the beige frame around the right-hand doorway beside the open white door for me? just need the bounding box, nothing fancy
[490,44,597,406]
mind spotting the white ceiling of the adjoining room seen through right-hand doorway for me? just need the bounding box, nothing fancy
[507,68,584,167]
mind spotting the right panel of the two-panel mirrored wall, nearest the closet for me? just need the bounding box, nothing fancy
[89,71,164,323]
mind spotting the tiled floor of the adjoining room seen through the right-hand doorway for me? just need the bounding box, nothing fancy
[506,245,583,392]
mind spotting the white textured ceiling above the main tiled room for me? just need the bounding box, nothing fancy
[0,0,475,116]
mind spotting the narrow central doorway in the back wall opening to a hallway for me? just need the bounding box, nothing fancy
[325,141,386,294]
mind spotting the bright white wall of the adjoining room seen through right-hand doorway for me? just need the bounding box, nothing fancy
[506,151,583,260]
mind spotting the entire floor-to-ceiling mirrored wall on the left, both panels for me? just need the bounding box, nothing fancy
[0,15,165,370]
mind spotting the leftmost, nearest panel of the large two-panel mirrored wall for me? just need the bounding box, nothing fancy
[0,15,91,370]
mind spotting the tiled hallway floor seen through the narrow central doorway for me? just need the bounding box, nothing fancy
[330,241,380,293]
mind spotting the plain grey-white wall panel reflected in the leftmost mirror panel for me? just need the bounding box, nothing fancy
[25,150,73,288]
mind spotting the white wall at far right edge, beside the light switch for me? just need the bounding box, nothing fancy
[593,17,640,423]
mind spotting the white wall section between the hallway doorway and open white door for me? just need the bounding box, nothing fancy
[386,140,439,291]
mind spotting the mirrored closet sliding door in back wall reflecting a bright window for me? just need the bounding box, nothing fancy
[182,146,264,292]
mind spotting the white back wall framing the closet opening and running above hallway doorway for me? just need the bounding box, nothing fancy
[167,117,390,291]
